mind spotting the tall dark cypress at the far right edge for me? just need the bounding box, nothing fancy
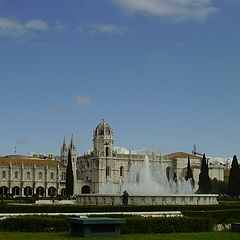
[227,155,240,197]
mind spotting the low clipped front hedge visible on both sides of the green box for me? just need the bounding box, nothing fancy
[0,216,214,233]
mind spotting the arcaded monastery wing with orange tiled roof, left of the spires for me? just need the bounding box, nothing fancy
[0,156,66,197]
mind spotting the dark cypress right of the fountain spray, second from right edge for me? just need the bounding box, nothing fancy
[198,154,211,193]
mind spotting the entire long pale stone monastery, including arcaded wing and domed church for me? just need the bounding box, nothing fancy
[0,120,228,196]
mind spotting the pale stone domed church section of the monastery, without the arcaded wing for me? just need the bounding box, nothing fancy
[61,120,224,195]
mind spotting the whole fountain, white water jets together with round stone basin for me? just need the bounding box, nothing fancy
[76,155,218,205]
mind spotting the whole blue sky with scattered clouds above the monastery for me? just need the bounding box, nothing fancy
[0,0,240,157]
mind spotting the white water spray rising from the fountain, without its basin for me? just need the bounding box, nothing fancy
[100,155,195,196]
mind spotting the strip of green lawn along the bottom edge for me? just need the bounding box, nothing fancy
[0,232,240,240]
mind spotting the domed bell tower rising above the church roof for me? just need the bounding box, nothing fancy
[93,119,114,157]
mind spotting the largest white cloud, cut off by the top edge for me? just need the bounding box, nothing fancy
[110,0,219,21]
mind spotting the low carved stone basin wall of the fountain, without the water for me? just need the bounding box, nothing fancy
[75,194,218,205]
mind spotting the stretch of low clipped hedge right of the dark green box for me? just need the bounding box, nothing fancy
[121,217,214,233]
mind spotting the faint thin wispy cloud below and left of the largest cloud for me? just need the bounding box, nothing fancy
[78,23,127,35]
